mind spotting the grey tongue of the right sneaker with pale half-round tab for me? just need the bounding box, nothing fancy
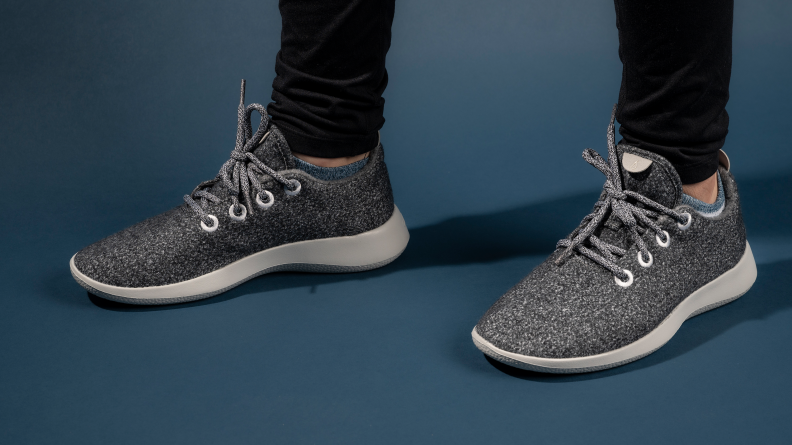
[616,144,682,208]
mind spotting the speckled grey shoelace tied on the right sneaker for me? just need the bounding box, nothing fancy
[556,106,689,281]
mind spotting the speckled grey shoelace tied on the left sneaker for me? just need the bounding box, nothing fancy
[184,79,298,226]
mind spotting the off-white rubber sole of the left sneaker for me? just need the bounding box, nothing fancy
[69,206,410,305]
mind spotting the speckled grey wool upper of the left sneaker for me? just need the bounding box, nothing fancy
[74,125,394,287]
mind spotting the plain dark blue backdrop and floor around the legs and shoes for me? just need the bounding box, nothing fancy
[0,0,792,444]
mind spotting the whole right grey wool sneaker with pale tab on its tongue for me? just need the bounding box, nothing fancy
[472,109,756,373]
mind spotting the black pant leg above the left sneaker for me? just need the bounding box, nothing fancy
[267,0,395,158]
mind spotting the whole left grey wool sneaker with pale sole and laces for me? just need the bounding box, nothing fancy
[70,81,409,304]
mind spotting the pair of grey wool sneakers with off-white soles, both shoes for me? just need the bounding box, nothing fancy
[70,84,756,373]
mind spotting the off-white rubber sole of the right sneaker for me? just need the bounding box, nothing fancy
[473,242,756,374]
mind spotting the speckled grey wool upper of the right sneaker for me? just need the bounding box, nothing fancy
[476,145,746,358]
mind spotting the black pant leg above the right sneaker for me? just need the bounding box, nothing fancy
[615,0,734,184]
